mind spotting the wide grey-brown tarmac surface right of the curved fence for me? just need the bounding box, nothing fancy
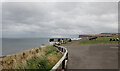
[63,42,118,69]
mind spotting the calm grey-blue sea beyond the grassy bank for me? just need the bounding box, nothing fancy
[0,38,49,56]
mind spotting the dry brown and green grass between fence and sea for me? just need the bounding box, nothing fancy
[0,46,62,71]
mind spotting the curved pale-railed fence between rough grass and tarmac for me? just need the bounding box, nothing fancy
[51,45,68,71]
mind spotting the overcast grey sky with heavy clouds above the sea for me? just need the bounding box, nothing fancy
[2,2,118,37]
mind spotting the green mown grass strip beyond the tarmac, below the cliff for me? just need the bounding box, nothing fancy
[77,36,118,44]
